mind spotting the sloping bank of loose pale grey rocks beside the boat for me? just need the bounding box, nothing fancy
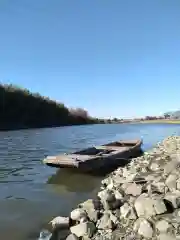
[40,136,180,240]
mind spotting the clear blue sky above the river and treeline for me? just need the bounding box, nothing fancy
[0,0,180,117]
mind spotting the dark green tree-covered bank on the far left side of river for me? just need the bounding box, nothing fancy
[0,84,99,130]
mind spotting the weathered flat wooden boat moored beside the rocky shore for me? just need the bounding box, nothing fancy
[43,140,142,172]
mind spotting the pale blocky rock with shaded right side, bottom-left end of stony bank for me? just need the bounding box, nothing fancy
[70,222,96,237]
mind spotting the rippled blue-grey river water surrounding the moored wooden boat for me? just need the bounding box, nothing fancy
[0,124,180,240]
